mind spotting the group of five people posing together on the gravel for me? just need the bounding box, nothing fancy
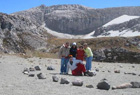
[59,42,93,76]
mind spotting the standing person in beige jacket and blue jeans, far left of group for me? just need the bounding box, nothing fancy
[59,42,70,74]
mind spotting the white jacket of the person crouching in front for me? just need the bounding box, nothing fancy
[66,59,83,73]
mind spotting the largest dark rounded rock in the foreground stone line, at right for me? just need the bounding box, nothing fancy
[97,79,110,90]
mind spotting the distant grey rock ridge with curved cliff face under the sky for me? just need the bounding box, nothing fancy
[13,5,140,35]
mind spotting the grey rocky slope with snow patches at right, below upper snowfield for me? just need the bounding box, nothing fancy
[93,17,140,37]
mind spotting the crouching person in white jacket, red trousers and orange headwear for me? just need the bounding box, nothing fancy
[67,55,86,76]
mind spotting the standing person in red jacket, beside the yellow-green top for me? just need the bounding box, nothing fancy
[76,45,85,61]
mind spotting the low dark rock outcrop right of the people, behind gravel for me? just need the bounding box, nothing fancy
[94,48,140,63]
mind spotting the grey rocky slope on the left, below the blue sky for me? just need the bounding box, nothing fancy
[0,13,54,53]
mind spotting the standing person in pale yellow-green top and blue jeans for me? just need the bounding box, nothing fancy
[84,43,93,71]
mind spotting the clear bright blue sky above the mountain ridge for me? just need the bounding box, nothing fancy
[0,0,140,14]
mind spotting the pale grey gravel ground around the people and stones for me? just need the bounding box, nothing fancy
[0,55,140,95]
